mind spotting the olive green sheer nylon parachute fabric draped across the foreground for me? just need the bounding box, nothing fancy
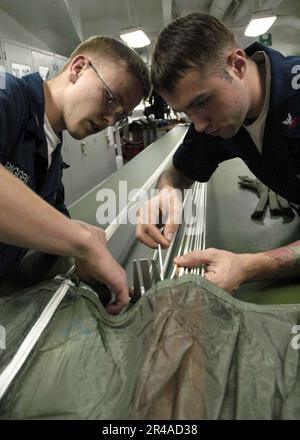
[0,275,300,419]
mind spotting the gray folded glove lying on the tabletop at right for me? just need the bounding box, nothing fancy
[238,176,295,219]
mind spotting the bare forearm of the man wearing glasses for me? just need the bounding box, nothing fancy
[0,166,89,257]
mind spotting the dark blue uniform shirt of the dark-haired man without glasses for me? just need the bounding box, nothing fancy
[173,43,300,204]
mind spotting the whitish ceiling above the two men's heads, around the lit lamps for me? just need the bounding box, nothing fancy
[0,0,300,56]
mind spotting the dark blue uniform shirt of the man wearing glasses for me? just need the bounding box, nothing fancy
[0,73,69,277]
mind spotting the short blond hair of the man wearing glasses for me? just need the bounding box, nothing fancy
[61,35,151,99]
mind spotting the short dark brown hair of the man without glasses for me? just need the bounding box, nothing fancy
[151,12,238,93]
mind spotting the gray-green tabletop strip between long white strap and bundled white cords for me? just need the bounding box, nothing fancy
[70,126,187,285]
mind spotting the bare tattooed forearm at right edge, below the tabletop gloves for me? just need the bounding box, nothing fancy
[248,241,300,281]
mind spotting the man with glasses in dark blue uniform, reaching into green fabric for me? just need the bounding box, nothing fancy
[0,36,150,313]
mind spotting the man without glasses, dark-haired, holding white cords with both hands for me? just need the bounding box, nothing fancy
[137,13,300,291]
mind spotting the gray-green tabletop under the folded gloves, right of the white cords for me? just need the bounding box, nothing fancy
[206,159,300,304]
